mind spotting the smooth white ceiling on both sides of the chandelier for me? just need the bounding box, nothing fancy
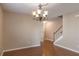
[1,3,79,19]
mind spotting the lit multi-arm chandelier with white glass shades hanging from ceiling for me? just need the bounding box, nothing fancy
[32,4,48,21]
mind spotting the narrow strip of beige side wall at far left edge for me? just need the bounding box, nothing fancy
[0,6,3,54]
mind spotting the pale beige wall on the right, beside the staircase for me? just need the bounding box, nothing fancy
[55,11,79,52]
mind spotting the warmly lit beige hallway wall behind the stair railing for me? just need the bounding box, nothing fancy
[46,17,62,41]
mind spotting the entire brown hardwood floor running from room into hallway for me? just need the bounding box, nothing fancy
[3,40,79,56]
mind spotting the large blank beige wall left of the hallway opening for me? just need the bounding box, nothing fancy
[3,12,42,49]
